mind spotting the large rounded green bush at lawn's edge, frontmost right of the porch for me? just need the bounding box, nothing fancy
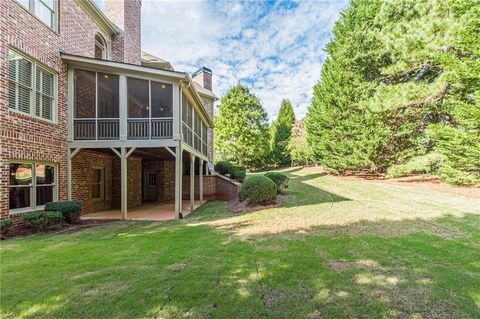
[240,175,277,204]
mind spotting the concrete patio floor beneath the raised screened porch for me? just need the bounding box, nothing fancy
[80,200,200,221]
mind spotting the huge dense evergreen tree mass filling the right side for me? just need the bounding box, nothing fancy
[306,0,480,185]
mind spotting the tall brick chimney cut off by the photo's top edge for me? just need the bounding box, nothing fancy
[105,0,142,64]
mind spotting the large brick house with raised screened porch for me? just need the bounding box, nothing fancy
[0,0,232,224]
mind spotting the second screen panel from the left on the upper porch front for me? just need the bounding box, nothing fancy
[97,73,120,140]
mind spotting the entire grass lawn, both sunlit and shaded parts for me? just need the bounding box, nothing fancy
[0,169,480,318]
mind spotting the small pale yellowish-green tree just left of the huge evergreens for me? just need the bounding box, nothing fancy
[286,120,313,165]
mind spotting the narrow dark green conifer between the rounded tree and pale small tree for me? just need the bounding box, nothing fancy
[270,99,295,165]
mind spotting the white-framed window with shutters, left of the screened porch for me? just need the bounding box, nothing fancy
[8,49,57,122]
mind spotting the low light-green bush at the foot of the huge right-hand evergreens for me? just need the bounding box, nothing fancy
[385,153,445,178]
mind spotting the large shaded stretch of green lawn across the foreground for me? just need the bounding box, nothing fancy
[1,215,480,318]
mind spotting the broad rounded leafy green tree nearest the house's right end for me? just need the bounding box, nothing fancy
[215,84,269,168]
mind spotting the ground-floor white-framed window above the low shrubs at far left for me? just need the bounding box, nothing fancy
[9,161,57,213]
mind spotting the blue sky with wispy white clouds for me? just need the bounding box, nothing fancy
[101,0,348,119]
